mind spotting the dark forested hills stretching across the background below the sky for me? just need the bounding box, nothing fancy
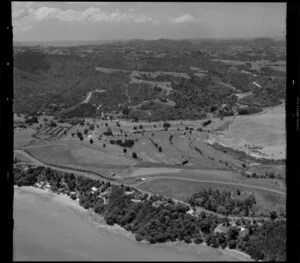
[14,39,285,120]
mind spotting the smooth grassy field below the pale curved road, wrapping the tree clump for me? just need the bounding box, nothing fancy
[139,178,286,217]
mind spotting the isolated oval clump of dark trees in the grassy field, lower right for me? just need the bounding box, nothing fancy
[189,188,256,219]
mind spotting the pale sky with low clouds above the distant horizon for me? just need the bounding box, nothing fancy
[12,2,286,41]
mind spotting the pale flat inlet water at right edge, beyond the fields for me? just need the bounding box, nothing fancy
[216,106,286,159]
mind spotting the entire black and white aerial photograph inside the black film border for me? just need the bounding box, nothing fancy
[11,1,287,262]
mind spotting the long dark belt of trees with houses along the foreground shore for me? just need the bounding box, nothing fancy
[14,167,286,261]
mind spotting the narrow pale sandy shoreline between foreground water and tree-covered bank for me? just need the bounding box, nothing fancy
[14,185,253,261]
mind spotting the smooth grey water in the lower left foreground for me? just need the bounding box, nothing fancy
[14,187,247,261]
